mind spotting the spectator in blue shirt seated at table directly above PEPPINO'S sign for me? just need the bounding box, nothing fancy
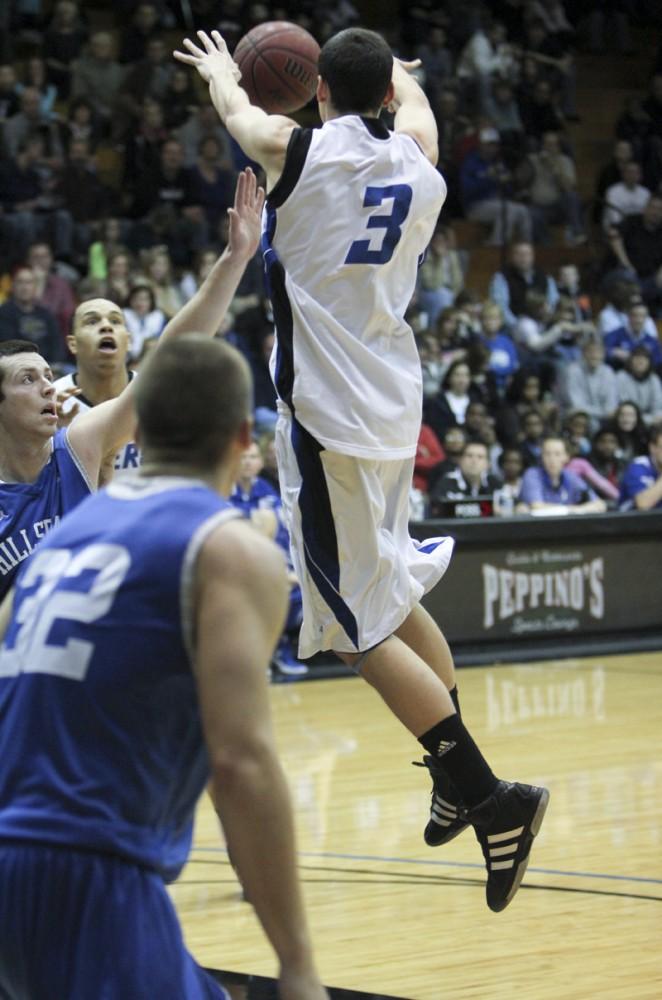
[517,437,607,514]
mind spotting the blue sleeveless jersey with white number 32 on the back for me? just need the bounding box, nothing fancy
[0,477,239,880]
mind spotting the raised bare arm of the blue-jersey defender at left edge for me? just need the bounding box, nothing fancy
[68,168,264,483]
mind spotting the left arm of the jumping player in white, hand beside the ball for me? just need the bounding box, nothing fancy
[174,31,297,188]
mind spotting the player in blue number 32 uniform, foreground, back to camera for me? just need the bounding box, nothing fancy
[0,335,326,1000]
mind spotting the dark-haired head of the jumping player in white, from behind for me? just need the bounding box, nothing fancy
[318,28,393,114]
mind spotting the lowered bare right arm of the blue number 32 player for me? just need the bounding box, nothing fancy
[195,521,326,1000]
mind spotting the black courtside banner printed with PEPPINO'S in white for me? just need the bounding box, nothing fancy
[423,524,662,643]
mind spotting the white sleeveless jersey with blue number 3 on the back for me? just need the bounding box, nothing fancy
[262,115,446,459]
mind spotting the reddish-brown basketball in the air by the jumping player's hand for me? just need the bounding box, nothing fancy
[233,21,320,114]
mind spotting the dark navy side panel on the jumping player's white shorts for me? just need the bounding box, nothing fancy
[292,419,359,649]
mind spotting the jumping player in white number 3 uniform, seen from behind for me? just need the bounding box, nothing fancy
[176,28,549,911]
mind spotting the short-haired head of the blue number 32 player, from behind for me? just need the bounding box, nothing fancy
[135,333,253,469]
